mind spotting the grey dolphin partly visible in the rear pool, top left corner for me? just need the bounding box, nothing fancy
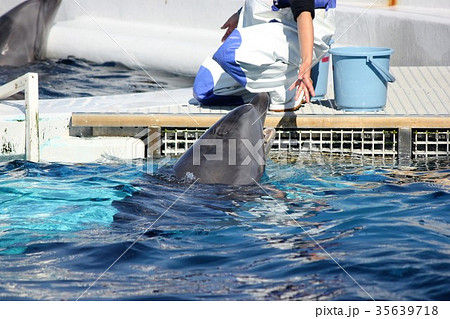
[0,0,61,66]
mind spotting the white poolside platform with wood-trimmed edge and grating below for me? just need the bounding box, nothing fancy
[0,66,450,162]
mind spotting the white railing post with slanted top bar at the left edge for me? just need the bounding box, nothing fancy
[0,73,40,162]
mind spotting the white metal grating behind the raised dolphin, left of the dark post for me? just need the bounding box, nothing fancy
[161,128,397,157]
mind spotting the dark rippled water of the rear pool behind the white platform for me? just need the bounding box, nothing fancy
[0,57,193,99]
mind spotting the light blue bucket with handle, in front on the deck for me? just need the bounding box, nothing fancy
[330,47,395,111]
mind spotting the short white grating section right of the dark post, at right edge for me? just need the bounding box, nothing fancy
[413,129,450,158]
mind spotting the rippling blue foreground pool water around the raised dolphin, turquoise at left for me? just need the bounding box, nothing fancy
[0,158,450,300]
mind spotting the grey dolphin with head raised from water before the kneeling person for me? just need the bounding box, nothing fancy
[174,93,275,185]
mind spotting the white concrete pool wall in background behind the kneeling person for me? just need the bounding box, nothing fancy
[0,0,450,71]
